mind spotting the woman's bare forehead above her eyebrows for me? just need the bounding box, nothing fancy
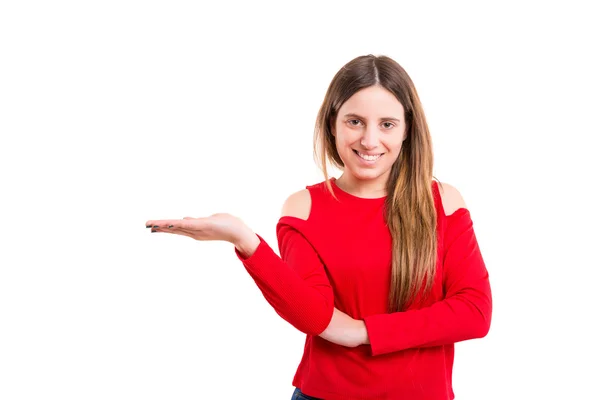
[339,86,404,118]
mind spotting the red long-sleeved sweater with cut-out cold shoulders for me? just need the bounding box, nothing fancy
[235,178,492,400]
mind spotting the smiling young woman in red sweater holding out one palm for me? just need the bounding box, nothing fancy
[146,55,492,400]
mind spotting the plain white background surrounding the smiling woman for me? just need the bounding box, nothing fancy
[0,1,600,400]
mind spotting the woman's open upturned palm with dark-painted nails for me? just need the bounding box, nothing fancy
[146,213,259,253]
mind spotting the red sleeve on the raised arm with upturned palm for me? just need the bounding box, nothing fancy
[235,224,333,336]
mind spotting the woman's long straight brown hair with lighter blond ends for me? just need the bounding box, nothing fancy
[314,54,439,312]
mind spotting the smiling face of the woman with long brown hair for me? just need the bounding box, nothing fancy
[334,86,406,183]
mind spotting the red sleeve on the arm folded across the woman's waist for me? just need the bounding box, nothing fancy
[364,208,492,356]
